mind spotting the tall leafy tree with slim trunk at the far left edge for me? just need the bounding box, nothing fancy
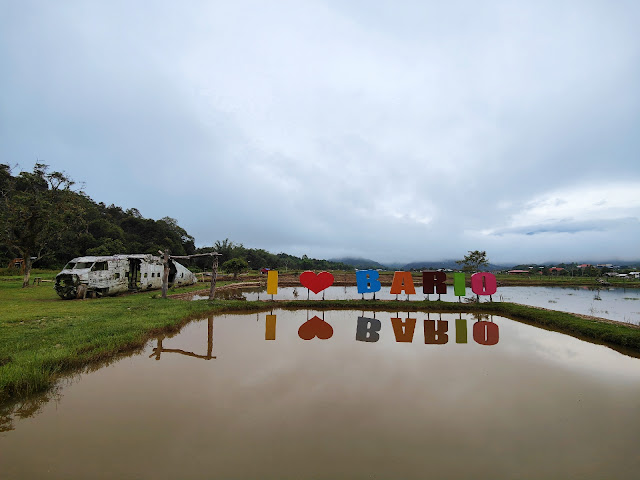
[0,163,82,287]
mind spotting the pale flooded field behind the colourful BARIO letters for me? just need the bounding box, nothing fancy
[228,285,640,325]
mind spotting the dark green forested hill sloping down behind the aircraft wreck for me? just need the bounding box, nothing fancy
[0,164,352,270]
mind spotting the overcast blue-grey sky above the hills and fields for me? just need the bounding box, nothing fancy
[0,0,640,264]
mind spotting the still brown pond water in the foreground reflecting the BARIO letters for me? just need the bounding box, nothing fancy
[0,311,640,480]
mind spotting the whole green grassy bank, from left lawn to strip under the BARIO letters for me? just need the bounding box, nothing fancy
[0,278,640,402]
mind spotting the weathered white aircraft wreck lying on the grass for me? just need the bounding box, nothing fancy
[54,254,197,299]
